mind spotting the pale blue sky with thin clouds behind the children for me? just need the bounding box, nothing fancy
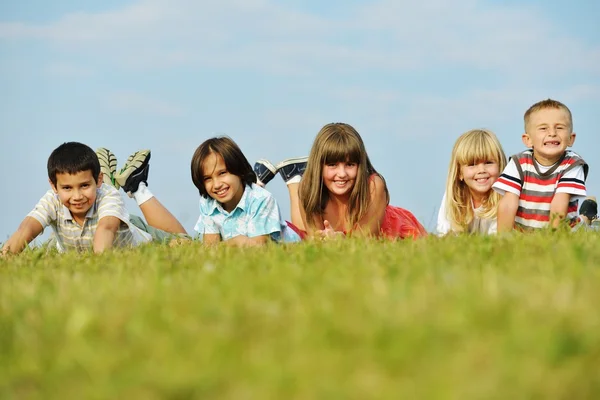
[0,0,600,240]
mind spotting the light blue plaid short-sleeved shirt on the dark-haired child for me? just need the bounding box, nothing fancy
[194,184,300,242]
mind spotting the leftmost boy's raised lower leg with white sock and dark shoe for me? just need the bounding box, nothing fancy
[116,150,187,234]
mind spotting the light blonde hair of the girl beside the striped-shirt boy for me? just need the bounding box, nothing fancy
[446,129,506,232]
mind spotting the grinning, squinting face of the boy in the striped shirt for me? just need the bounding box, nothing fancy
[523,108,575,165]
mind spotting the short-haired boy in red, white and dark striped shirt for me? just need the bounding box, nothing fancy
[493,99,588,232]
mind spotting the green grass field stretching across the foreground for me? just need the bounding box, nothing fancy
[0,233,600,399]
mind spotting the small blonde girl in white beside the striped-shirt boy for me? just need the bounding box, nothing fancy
[436,129,506,236]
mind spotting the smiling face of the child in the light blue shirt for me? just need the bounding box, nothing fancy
[202,153,244,212]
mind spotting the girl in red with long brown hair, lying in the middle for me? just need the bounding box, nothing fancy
[298,123,427,238]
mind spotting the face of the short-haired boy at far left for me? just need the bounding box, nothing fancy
[50,170,102,221]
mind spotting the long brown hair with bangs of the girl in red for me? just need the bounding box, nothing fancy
[298,122,389,229]
